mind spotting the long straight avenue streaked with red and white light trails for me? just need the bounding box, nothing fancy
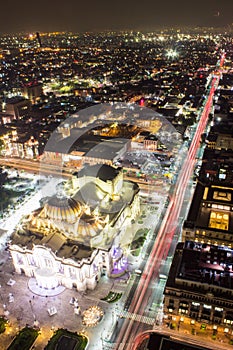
[114,62,223,350]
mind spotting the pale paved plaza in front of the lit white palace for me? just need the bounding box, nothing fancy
[0,252,127,350]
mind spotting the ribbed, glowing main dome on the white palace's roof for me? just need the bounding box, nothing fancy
[44,196,82,222]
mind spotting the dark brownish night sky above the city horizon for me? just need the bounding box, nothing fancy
[0,0,233,34]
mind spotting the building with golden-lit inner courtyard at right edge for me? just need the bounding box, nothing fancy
[182,182,233,247]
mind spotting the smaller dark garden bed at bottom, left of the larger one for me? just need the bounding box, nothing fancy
[7,327,39,350]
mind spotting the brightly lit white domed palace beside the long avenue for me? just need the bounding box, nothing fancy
[9,165,140,291]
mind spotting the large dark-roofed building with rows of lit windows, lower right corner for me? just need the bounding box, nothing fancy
[164,241,233,326]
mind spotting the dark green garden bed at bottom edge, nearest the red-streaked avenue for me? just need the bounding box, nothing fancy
[45,329,88,350]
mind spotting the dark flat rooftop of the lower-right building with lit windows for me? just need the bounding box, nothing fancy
[166,241,233,299]
